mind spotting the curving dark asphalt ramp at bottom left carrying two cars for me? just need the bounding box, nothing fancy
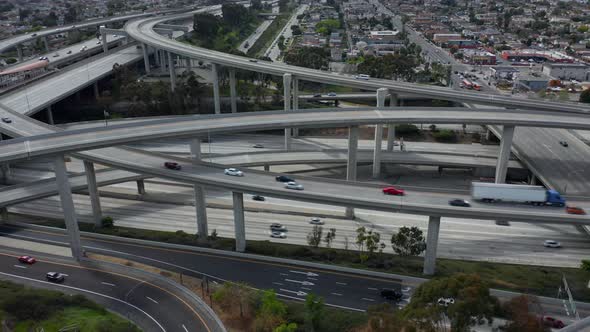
[0,248,211,332]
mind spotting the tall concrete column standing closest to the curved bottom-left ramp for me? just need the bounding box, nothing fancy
[53,155,83,261]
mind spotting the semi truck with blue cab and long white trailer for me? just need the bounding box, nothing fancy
[471,182,565,206]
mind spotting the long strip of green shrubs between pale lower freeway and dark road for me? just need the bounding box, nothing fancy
[35,221,590,301]
